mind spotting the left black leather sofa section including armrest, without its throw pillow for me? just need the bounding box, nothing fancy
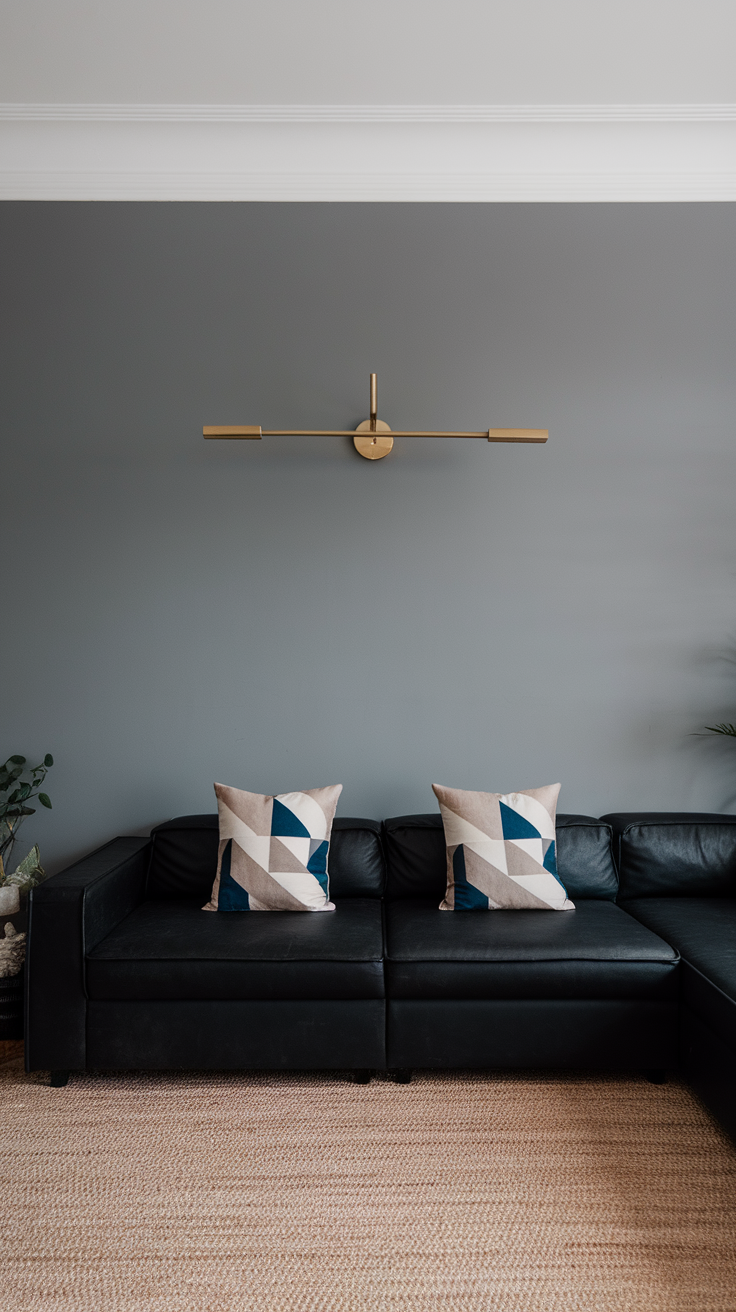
[26,815,386,1071]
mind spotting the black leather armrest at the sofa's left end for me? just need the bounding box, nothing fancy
[25,838,151,1071]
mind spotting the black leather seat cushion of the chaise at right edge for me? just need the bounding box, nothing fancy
[626,897,736,1050]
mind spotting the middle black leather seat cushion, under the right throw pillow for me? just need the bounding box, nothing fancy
[386,897,678,1000]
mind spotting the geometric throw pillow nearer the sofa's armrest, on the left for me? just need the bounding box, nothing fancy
[202,783,342,911]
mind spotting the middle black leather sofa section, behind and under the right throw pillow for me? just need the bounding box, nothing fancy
[384,815,678,1069]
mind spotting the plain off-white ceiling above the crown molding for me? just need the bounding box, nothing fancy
[0,0,736,105]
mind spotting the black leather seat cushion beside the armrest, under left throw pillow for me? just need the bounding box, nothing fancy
[87,897,383,1001]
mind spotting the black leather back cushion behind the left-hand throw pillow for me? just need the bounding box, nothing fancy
[146,815,384,905]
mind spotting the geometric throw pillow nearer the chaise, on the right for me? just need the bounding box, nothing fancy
[432,783,575,911]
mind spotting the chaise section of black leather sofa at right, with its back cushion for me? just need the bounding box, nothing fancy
[603,812,736,1135]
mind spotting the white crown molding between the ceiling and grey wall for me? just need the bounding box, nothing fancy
[0,105,736,202]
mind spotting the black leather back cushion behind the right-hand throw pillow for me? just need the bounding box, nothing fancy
[383,815,618,905]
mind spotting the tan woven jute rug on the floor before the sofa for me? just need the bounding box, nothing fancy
[0,1051,736,1312]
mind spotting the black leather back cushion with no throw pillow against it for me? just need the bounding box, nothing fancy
[602,811,736,899]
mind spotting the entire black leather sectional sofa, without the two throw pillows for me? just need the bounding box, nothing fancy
[26,813,736,1132]
